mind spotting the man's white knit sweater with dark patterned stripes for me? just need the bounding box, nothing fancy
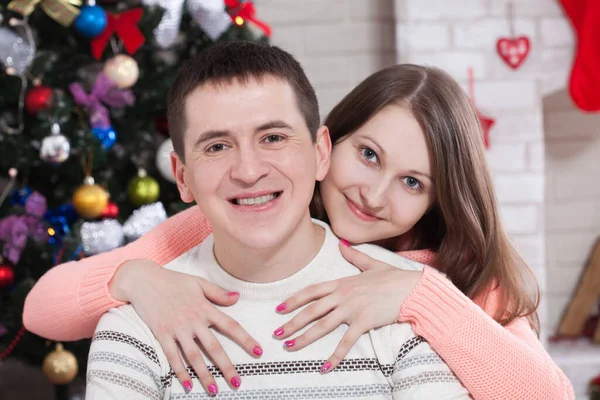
[86,221,469,400]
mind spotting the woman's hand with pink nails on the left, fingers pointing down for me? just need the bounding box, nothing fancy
[109,260,262,395]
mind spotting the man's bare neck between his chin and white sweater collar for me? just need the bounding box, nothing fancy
[214,218,325,282]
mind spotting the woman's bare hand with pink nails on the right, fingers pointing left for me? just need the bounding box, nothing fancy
[275,242,421,372]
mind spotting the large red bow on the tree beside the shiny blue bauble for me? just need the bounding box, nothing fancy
[92,7,146,60]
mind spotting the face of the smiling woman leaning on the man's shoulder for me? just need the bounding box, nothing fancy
[321,105,435,243]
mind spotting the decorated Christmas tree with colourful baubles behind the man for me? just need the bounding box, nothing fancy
[0,0,269,394]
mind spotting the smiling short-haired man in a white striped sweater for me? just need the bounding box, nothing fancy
[87,42,468,399]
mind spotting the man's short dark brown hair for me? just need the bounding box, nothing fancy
[167,41,320,160]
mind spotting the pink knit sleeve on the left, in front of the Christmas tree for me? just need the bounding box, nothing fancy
[23,206,210,340]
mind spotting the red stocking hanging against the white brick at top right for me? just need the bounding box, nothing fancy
[560,0,600,111]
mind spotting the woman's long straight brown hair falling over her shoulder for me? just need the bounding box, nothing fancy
[311,64,539,329]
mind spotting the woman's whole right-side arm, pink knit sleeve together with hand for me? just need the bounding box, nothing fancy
[270,242,575,400]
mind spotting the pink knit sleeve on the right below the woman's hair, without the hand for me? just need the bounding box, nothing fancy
[399,267,575,400]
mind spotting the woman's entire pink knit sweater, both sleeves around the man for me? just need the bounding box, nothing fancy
[23,207,575,400]
